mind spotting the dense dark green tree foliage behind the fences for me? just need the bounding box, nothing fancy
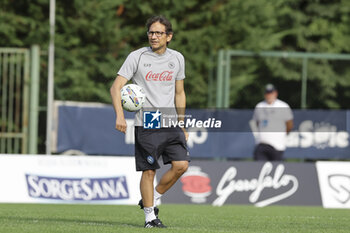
[0,0,350,108]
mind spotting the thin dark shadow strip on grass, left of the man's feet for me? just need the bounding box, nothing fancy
[0,216,143,228]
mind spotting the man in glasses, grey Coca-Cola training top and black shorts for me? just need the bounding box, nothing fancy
[110,16,190,228]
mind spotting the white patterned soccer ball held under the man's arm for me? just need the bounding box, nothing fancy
[120,84,146,112]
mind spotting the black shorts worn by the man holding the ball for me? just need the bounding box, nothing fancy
[135,126,190,171]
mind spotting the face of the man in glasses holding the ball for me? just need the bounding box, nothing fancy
[148,22,173,52]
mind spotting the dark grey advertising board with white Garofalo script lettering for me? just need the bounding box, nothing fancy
[157,161,322,207]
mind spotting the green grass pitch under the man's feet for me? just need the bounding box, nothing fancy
[0,204,350,233]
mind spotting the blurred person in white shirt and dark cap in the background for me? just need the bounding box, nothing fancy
[253,84,293,161]
